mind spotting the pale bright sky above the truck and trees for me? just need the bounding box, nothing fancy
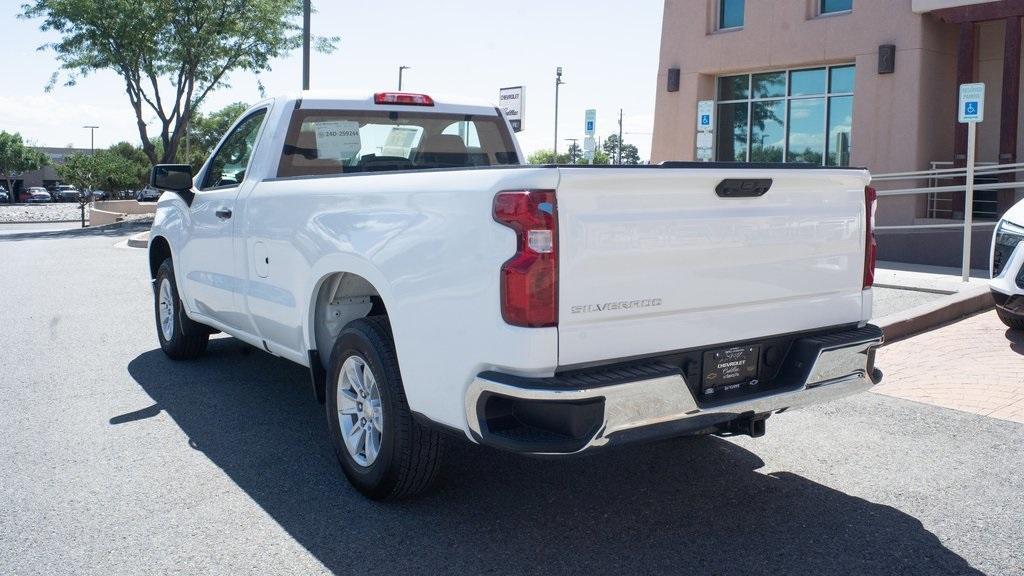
[0,0,663,159]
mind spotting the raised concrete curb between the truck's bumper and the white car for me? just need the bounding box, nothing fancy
[872,285,994,343]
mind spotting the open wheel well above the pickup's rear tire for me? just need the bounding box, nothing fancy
[312,272,387,369]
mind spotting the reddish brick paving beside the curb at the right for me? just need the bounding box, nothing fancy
[872,311,1024,423]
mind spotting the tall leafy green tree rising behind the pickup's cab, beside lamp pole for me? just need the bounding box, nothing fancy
[20,0,338,164]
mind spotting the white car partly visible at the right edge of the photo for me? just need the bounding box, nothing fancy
[989,202,1024,330]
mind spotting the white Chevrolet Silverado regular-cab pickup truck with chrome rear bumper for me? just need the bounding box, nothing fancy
[148,92,882,498]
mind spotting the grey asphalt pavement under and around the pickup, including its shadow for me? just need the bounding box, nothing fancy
[0,229,1024,576]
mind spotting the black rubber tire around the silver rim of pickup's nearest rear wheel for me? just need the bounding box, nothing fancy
[325,316,443,500]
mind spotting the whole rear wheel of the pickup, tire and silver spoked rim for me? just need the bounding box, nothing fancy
[326,316,442,500]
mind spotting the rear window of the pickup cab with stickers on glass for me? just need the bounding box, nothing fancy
[278,110,518,177]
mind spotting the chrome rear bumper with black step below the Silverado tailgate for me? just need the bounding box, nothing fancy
[466,325,883,454]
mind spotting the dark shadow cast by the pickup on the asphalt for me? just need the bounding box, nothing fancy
[123,338,980,575]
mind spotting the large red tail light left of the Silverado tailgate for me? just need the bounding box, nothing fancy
[494,190,558,328]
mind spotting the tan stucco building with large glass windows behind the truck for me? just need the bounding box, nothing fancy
[651,0,1024,265]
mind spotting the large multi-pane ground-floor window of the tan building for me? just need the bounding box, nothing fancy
[715,65,854,166]
